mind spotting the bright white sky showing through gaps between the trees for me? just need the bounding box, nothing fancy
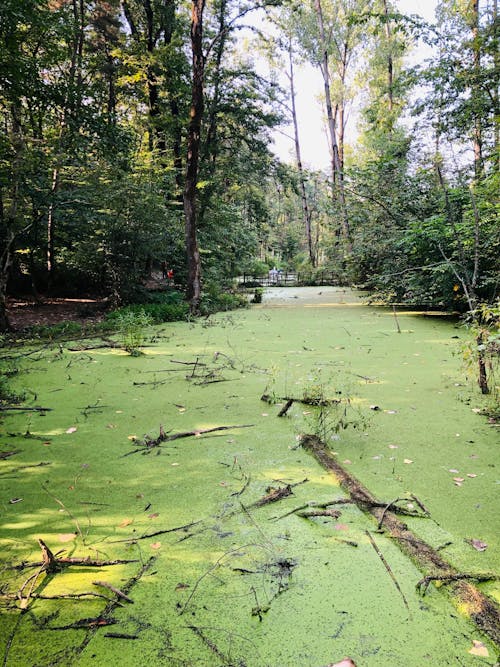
[273,0,437,170]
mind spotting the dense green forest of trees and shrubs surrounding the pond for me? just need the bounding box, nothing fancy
[0,0,500,330]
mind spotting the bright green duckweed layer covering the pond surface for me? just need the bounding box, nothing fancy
[0,288,500,667]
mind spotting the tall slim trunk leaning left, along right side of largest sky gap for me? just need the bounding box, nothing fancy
[314,0,352,252]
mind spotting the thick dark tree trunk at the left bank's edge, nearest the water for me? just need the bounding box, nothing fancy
[184,0,205,312]
